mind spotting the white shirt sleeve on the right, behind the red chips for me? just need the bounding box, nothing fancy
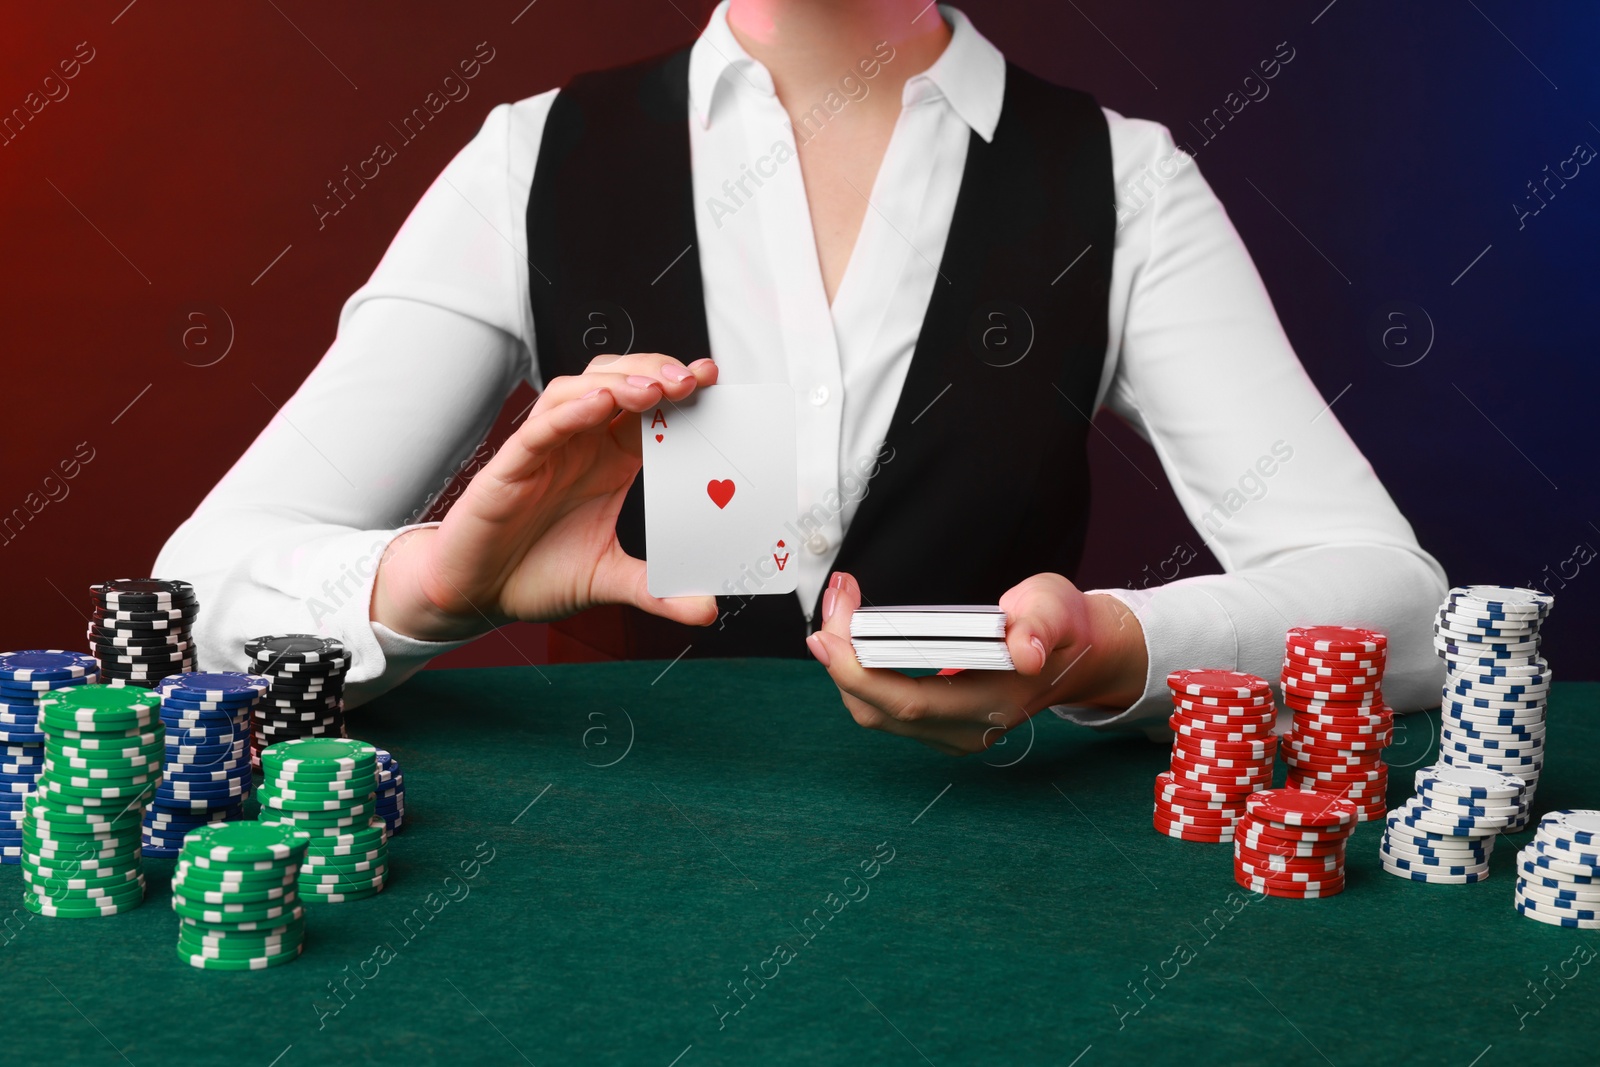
[1056,112,1445,733]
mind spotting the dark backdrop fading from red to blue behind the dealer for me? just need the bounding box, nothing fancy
[0,0,1600,678]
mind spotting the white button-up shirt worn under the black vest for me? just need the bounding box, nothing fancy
[157,0,1445,735]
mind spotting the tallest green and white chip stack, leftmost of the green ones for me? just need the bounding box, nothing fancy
[22,685,166,918]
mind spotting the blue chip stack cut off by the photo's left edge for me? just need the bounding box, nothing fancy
[0,648,99,864]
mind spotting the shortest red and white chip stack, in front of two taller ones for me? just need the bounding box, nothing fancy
[1234,789,1358,899]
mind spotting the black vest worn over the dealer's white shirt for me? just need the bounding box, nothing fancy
[528,50,1115,659]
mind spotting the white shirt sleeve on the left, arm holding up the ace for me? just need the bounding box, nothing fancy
[155,91,555,704]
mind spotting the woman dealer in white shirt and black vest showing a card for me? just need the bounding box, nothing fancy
[157,0,1445,752]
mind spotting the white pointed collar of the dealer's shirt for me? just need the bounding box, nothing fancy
[690,0,1005,141]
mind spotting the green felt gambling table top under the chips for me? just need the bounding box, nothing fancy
[0,661,1600,1067]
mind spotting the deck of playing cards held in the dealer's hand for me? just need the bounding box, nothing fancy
[850,605,1014,670]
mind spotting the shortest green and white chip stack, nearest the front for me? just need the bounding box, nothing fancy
[173,822,309,971]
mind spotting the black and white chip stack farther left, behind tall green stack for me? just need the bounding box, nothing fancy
[88,577,200,689]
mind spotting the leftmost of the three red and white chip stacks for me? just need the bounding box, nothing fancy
[1154,670,1278,841]
